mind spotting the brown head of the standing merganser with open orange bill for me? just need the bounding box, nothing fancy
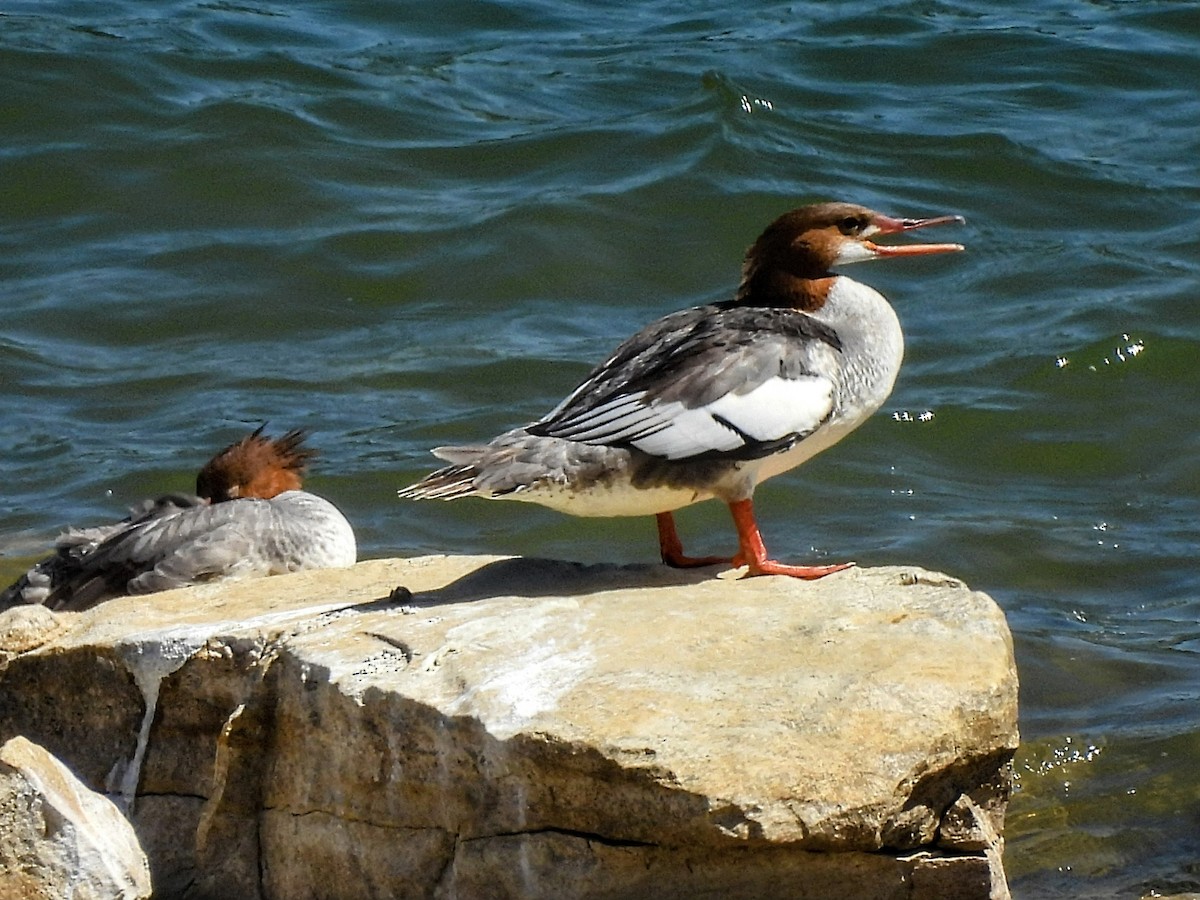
[737,203,966,311]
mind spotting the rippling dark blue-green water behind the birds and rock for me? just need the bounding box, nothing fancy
[0,0,1200,898]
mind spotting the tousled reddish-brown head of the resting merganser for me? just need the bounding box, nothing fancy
[196,425,317,503]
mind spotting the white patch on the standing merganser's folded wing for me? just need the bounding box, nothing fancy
[556,376,833,460]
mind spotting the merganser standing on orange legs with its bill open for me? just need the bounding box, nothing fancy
[400,203,965,578]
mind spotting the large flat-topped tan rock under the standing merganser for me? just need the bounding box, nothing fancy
[0,557,1016,898]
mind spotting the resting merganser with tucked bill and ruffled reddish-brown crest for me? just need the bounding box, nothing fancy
[0,426,358,611]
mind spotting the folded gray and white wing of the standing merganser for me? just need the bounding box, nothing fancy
[527,305,841,460]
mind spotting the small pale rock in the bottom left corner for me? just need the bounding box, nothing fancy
[0,737,150,900]
